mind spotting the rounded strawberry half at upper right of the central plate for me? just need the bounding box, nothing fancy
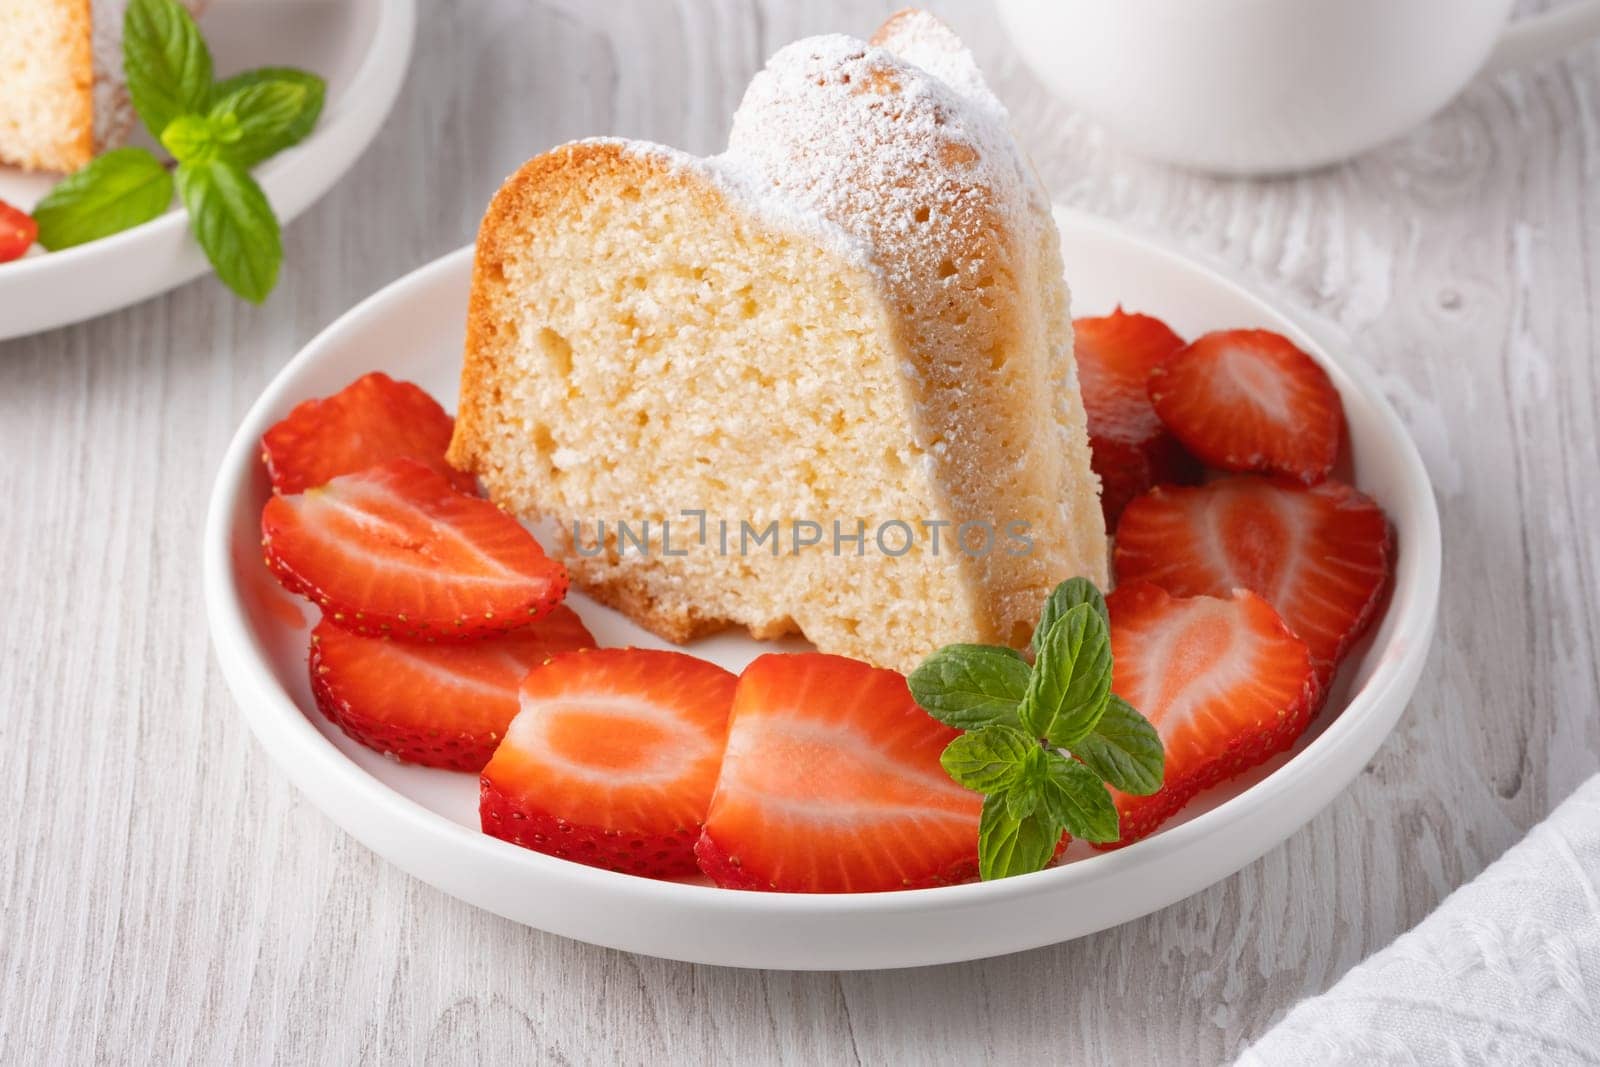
[1149,330,1344,485]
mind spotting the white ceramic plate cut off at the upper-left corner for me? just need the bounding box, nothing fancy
[0,0,416,341]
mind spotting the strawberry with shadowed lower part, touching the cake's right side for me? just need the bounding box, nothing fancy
[1072,307,1200,528]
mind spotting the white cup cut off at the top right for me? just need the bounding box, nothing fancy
[997,0,1600,174]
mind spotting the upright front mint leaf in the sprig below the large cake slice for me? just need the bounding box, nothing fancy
[1019,603,1110,749]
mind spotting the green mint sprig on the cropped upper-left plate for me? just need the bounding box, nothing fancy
[35,0,326,304]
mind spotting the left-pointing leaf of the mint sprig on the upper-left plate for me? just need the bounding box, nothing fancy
[34,149,173,251]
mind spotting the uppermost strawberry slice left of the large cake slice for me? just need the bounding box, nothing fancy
[261,371,477,493]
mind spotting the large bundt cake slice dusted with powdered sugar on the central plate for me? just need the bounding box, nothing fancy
[450,13,1106,670]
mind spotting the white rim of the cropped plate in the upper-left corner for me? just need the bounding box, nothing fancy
[0,0,416,341]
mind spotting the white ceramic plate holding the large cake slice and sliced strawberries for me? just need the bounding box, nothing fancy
[205,213,1440,969]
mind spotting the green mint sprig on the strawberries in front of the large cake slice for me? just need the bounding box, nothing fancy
[909,577,1165,880]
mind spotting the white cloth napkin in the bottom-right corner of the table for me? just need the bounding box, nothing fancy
[1237,776,1600,1067]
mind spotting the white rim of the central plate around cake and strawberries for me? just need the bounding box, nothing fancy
[202,206,1442,940]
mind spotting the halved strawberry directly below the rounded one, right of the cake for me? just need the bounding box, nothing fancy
[1117,478,1394,689]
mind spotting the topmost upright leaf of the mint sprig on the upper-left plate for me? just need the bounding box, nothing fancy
[122,0,211,139]
